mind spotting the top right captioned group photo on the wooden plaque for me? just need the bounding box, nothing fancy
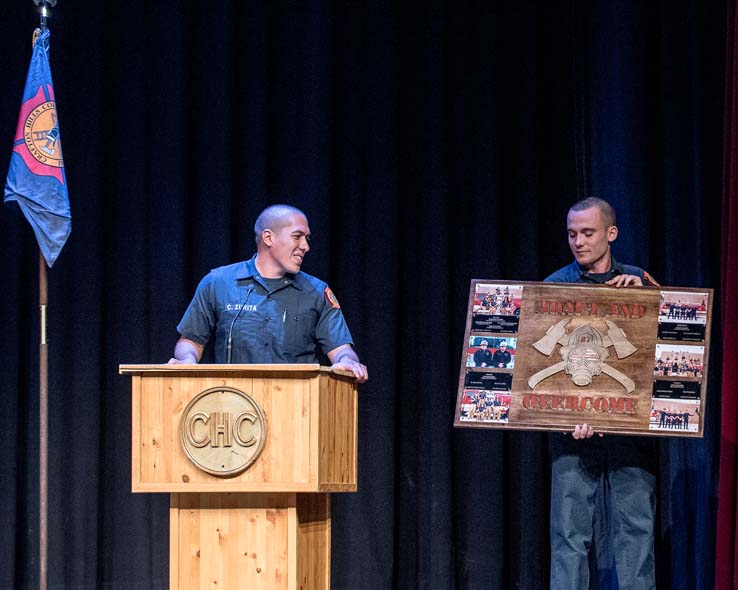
[658,291,708,342]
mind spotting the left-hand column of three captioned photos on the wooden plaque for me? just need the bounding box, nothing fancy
[459,283,523,424]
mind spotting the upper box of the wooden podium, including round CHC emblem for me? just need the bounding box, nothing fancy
[119,363,358,493]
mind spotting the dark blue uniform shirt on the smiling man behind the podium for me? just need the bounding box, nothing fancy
[177,257,353,363]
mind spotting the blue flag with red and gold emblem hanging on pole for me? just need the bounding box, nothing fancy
[5,29,72,266]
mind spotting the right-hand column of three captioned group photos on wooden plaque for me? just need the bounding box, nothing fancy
[648,291,709,433]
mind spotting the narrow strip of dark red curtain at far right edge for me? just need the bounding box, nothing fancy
[715,0,738,590]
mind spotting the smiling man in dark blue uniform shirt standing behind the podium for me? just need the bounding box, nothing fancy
[169,205,368,383]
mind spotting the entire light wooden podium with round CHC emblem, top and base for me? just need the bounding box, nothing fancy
[120,364,357,590]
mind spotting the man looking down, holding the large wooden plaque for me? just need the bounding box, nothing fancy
[546,197,658,590]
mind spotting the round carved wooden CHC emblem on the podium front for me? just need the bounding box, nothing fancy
[179,387,266,477]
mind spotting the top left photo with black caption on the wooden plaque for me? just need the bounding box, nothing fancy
[471,283,523,334]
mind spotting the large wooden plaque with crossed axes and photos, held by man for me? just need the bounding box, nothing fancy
[454,279,713,437]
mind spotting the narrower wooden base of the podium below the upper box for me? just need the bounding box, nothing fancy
[169,493,331,590]
